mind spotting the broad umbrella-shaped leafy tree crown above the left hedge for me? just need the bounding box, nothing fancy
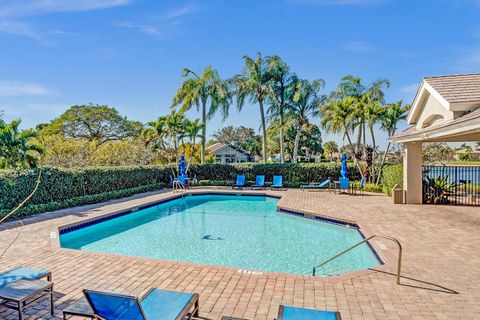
[40,104,143,145]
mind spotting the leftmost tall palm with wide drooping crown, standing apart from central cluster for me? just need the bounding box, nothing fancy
[172,66,230,164]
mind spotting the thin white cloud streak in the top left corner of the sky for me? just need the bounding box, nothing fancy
[0,0,133,17]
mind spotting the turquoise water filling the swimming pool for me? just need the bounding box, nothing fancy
[60,195,379,276]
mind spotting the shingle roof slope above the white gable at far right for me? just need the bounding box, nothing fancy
[425,73,480,103]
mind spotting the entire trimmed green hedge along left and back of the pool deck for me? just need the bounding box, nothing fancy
[0,163,360,217]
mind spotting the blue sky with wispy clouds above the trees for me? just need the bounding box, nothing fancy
[0,0,480,149]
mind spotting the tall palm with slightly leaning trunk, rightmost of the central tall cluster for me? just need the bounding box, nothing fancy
[288,80,325,162]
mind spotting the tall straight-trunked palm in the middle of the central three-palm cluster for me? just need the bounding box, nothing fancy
[265,56,296,163]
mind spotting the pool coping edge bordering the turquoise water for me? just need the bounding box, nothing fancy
[50,189,392,282]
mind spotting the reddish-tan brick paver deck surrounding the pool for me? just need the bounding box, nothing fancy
[0,190,480,320]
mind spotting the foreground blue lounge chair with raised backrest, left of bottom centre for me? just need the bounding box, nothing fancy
[83,288,198,320]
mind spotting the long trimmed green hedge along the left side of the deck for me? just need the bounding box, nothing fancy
[0,167,168,216]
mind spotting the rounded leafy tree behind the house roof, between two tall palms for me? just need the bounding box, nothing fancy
[211,126,262,156]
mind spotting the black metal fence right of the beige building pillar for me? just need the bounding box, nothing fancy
[423,166,480,206]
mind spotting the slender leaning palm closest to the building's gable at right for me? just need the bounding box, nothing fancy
[376,100,411,185]
